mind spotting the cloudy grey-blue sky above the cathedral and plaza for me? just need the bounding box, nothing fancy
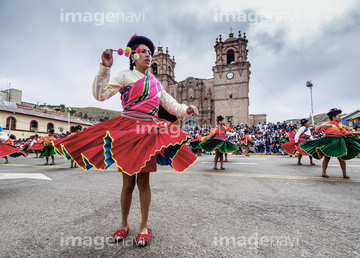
[0,0,360,122]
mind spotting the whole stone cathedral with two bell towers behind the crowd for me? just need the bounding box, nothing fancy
[150,31,266,126]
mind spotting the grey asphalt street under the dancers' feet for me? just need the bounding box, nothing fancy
[0,154,360,257]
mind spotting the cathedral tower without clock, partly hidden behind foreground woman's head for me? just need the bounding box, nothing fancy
[149,47,176,91]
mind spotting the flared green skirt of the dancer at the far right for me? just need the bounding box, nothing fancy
[299,136,360,160]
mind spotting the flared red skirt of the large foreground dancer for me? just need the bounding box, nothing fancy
[54,116,196,175]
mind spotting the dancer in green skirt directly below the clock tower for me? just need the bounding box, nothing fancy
[200,116,239,170]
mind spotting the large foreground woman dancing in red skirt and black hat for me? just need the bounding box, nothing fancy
[54,35,198,246]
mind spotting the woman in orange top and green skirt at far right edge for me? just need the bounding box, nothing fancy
[299,108,360,179]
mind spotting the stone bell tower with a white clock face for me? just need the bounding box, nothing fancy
[212,31,250,125]
